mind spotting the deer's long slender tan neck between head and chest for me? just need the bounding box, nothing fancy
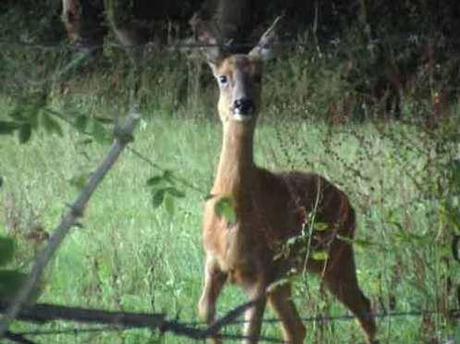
[212,123,256,197]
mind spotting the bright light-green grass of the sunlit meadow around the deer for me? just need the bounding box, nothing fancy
[0,98,452,343]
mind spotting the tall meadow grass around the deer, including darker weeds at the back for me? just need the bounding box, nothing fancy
[0,41,459,343]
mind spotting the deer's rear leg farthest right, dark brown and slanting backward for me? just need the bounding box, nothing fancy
[323,245,377,343]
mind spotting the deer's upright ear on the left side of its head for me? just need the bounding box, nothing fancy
[189,13,224,67]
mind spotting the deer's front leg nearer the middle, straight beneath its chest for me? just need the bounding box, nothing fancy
[243,281,267,344]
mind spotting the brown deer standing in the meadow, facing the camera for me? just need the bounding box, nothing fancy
[191,18,377,344]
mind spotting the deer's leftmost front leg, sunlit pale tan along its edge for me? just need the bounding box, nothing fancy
[198,255,227,343]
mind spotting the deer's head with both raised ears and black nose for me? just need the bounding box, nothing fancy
[192,18,279,126]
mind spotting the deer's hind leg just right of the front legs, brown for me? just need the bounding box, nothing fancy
[268,285,305,344]
